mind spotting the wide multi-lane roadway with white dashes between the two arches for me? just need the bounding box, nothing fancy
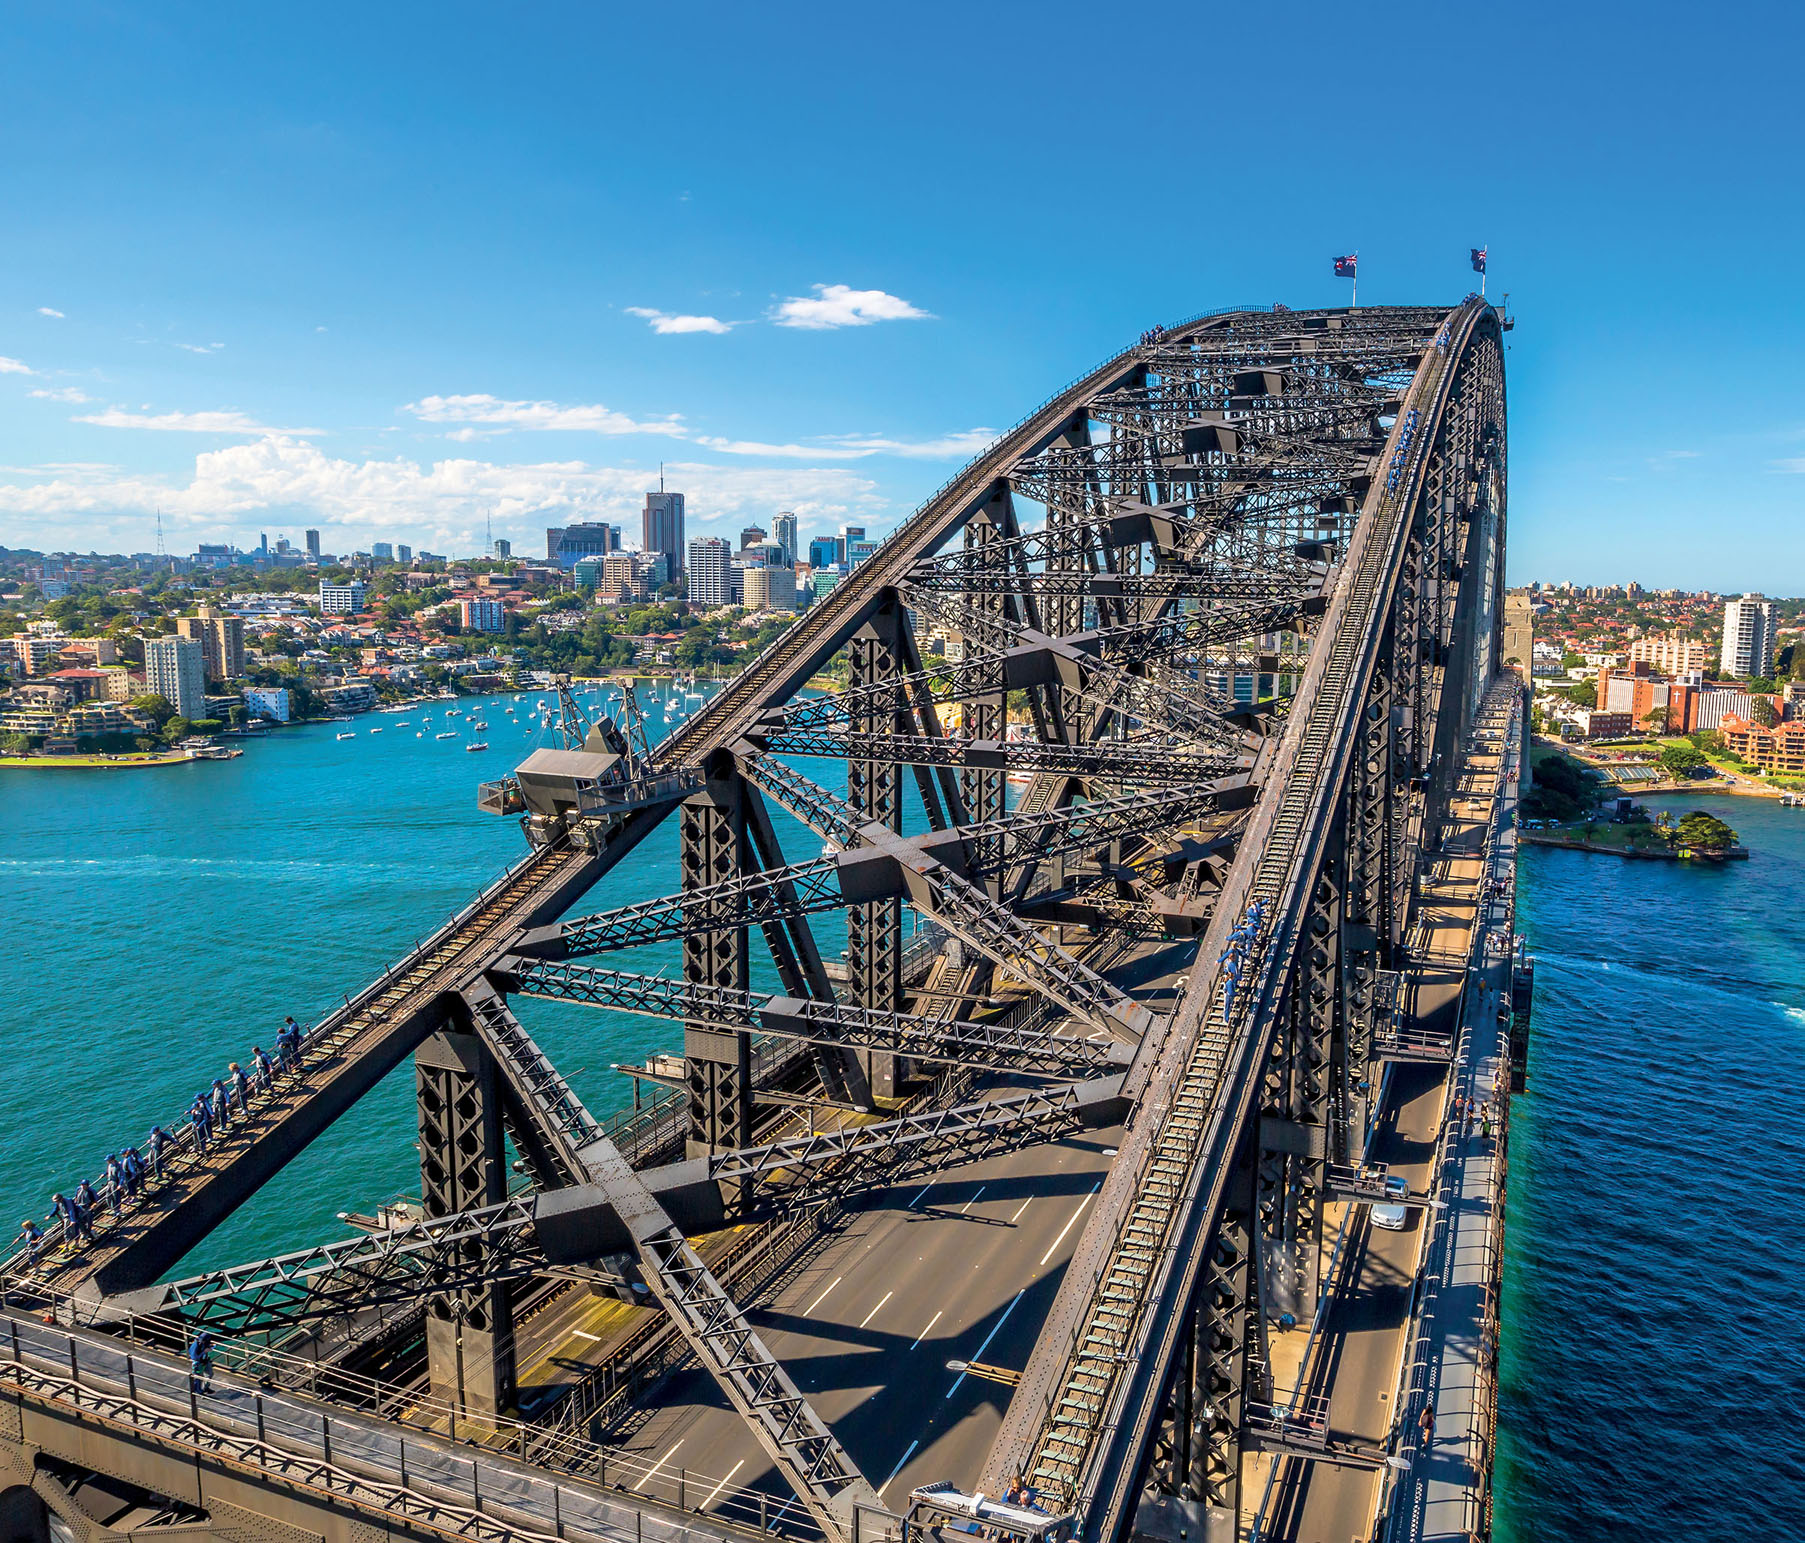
[435,942,1191,1520]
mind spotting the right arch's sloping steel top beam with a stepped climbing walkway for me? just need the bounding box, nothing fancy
[987,301,1502,1536]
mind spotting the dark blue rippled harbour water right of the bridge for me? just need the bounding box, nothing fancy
[1496,798,1805,1543]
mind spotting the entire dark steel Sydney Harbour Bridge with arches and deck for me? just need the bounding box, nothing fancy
[0,296,1520,1543]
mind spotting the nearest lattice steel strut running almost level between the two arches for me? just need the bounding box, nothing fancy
[495,958,1128,1077]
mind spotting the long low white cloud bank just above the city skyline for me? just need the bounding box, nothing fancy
[0,437,884,550]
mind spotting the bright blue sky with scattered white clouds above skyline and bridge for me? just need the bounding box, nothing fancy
[0,0,1805,594]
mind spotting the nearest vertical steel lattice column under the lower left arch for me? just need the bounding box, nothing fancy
[413,1029,514,1413]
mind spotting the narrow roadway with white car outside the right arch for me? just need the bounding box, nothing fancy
[1251,695,1514,1543]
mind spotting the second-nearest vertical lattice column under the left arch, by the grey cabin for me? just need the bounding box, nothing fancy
[677,754,753,1157]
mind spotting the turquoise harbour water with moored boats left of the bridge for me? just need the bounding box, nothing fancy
[0,693,845,1269]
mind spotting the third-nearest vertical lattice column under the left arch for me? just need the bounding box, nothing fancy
[847,596,913,1097]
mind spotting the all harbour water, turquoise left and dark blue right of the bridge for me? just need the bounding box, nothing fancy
[0,721,1805,1523]
